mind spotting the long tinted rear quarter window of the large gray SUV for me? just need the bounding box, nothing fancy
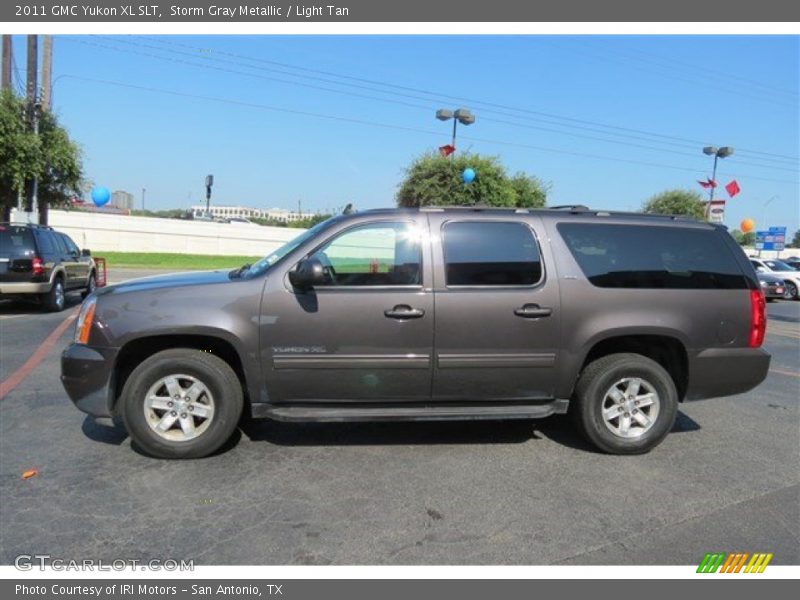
[558,223,747,289]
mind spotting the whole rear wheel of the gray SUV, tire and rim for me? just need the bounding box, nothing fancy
[570,353,678,454]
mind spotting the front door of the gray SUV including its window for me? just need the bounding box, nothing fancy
[261,215,433,403]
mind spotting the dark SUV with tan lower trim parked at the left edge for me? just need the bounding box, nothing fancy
[0,223,97,311]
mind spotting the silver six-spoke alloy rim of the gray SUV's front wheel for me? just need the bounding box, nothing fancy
[144,375,214,442]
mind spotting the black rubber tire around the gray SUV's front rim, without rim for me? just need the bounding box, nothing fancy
[119,348,244,458]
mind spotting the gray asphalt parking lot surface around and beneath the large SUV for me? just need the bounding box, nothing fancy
[0,271,800,565]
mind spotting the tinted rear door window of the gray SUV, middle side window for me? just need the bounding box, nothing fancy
[443,221,542,285]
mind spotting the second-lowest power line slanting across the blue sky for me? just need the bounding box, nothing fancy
[67,36,796,172]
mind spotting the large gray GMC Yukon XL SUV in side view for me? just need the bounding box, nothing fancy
[61,207,770,458]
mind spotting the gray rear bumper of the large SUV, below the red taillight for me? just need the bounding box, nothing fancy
[686,348,771,400]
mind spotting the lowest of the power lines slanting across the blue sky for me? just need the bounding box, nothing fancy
[56,74,797,184]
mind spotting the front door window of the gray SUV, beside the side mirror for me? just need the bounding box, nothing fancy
[313,223,422,286]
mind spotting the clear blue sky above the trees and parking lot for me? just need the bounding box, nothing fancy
[7,35,800,230]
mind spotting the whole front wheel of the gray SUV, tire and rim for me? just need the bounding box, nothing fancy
[120,348,244,458]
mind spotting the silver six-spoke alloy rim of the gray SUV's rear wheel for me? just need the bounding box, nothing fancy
[602,377,661,439]
